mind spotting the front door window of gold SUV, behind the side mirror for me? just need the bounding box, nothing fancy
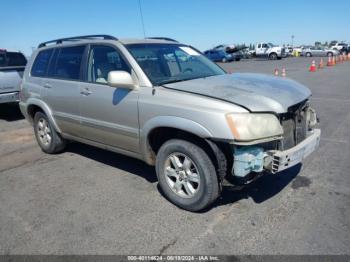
[87,45,131,84]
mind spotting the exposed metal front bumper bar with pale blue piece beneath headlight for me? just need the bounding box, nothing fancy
[232,129,321,178]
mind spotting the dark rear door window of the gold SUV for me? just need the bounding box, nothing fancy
[49,46,85,80]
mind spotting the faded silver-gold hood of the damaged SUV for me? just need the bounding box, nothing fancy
[164,73,311,114]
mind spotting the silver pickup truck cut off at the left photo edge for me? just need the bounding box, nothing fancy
[0,49,27,104]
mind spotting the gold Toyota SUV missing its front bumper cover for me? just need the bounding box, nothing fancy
[20,35,321,211]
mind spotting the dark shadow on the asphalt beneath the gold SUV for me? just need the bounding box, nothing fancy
[66,142,301,213]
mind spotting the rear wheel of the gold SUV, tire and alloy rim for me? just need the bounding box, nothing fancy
[34,112,66,154]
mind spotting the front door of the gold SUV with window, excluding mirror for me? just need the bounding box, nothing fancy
[79,45,139,152]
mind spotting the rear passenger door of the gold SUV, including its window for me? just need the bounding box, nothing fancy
[41,45,86,136]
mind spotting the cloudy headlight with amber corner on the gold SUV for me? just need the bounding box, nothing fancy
[226,113,283,141]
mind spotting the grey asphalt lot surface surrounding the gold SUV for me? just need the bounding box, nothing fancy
[0,58,350,255]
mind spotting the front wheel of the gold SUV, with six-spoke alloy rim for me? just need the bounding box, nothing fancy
[156,139,219,211]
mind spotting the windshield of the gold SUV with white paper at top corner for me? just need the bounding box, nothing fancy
[126,44,225,85]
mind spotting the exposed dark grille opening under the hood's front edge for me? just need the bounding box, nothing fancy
[279,101,308,150]
